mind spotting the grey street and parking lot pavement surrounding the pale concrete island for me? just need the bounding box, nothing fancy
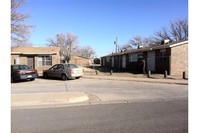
[11,79,188,133]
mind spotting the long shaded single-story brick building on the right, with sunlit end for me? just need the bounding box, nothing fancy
[101,40,188,75]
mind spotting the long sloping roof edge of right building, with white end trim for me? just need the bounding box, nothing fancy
[103,40,188,57]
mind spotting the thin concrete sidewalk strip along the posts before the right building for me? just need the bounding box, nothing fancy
[83,75,188,85]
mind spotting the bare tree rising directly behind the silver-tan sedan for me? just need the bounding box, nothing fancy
[47,33,79,62]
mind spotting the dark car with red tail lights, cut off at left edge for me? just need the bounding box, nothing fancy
[11,65,38,83]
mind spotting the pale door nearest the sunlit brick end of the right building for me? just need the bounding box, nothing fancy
[147,51,155,71]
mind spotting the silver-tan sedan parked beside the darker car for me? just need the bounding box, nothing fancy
[43,64,83,80]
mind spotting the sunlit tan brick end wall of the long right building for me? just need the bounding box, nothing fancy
[171,43,188,76]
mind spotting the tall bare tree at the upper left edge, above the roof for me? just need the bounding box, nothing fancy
[11,0,33,46]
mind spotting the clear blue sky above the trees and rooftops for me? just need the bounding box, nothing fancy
[21,0,188,57]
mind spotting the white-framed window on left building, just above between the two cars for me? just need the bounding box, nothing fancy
[38,55,52,66]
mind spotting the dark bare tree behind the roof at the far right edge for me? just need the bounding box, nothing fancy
[154,19,188,41]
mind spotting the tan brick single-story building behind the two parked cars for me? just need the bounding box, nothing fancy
[11,46,60,74]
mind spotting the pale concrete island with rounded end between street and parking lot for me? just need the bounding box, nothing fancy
[11,92,89,108]
